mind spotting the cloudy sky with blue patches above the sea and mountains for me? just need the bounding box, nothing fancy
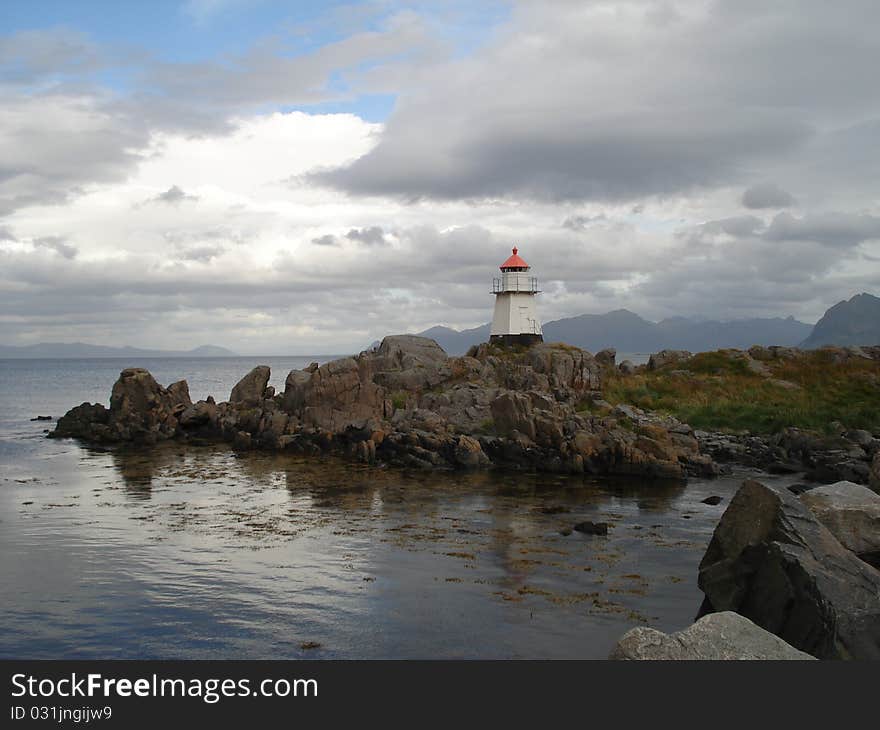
[0,0,880,354]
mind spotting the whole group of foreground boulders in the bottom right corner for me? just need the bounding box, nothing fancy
[610,480,880,660]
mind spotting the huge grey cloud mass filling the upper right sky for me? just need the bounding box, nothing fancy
[313,0,880,203]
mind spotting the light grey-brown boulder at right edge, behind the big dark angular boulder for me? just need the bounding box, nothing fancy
[801,482,880,568]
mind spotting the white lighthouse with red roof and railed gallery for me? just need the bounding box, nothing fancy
[489,247,544,345]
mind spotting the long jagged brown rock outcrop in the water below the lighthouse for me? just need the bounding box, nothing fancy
[48,335,716,479]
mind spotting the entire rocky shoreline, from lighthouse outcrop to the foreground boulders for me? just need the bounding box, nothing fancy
[49,335,880,659]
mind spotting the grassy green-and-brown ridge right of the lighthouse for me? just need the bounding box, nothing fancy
[603,350,880,434]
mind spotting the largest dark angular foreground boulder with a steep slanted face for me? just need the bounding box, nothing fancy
[699,480,880,659]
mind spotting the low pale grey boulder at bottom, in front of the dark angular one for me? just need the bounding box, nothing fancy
[608,611,815,661]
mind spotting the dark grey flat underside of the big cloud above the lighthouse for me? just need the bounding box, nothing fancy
[312,110,808,201]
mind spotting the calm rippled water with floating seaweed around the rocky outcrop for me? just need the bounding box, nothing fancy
[0,358,792,659]
